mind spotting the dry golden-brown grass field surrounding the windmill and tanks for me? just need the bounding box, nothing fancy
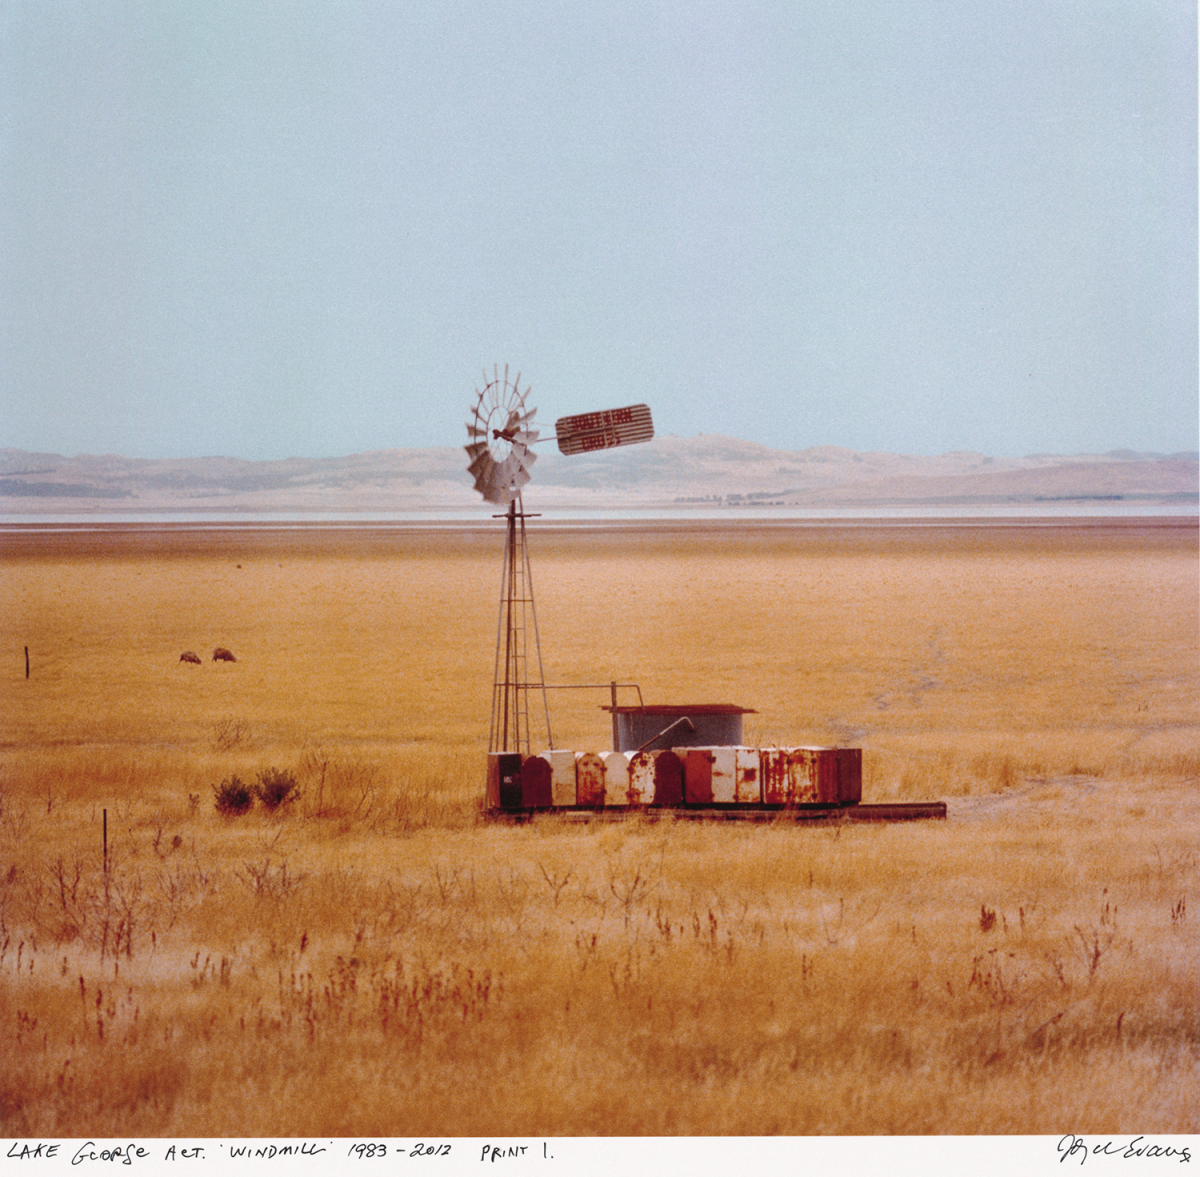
[0,520,1200,1136]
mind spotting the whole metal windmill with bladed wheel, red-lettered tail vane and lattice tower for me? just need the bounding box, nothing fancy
[466,364,654,756]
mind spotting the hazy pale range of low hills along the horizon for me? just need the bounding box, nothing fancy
[0,434,1200,517]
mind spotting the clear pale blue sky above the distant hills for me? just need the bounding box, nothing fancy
[0,0,1198,458]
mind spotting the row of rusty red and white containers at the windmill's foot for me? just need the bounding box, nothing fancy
[487,746,863,810]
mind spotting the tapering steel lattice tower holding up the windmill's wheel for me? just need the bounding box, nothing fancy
[487,494,554,756]
